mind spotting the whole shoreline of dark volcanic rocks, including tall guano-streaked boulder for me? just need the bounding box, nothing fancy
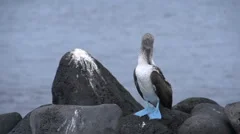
[0,49,240,134]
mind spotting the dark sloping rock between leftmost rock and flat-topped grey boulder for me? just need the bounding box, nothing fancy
[8,112,32,134]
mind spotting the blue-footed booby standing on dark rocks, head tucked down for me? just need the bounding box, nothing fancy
[133,33,172,119]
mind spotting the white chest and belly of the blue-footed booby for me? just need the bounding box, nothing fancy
[136,65,158,102]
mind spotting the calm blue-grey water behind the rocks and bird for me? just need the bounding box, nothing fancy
[0,0,240,115]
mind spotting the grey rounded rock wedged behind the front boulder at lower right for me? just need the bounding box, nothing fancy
[191,103,228,122]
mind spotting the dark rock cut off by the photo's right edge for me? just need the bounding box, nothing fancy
[224,102,240,134]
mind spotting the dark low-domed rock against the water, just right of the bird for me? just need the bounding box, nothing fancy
[173,97,217,113]
